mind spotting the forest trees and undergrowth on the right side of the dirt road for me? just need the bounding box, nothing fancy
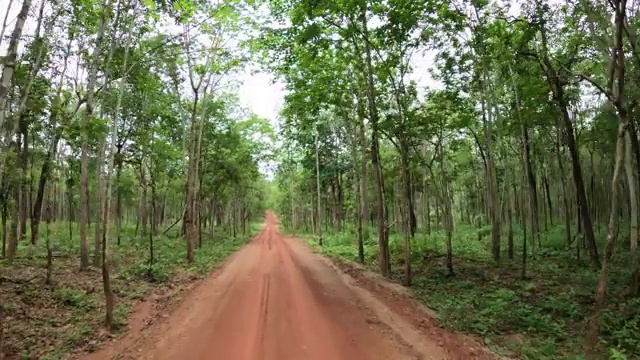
[257,0,640,360]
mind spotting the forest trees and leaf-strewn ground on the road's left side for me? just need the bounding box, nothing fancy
[0,0,274,359]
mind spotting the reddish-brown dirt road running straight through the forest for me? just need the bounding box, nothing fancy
[76,213,494,360]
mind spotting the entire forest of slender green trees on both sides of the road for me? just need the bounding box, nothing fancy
[0,0,640,360]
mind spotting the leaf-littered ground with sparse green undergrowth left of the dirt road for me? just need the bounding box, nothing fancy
[0,223,259,360]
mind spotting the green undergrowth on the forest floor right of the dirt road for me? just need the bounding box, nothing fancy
[296,221,640,359]
